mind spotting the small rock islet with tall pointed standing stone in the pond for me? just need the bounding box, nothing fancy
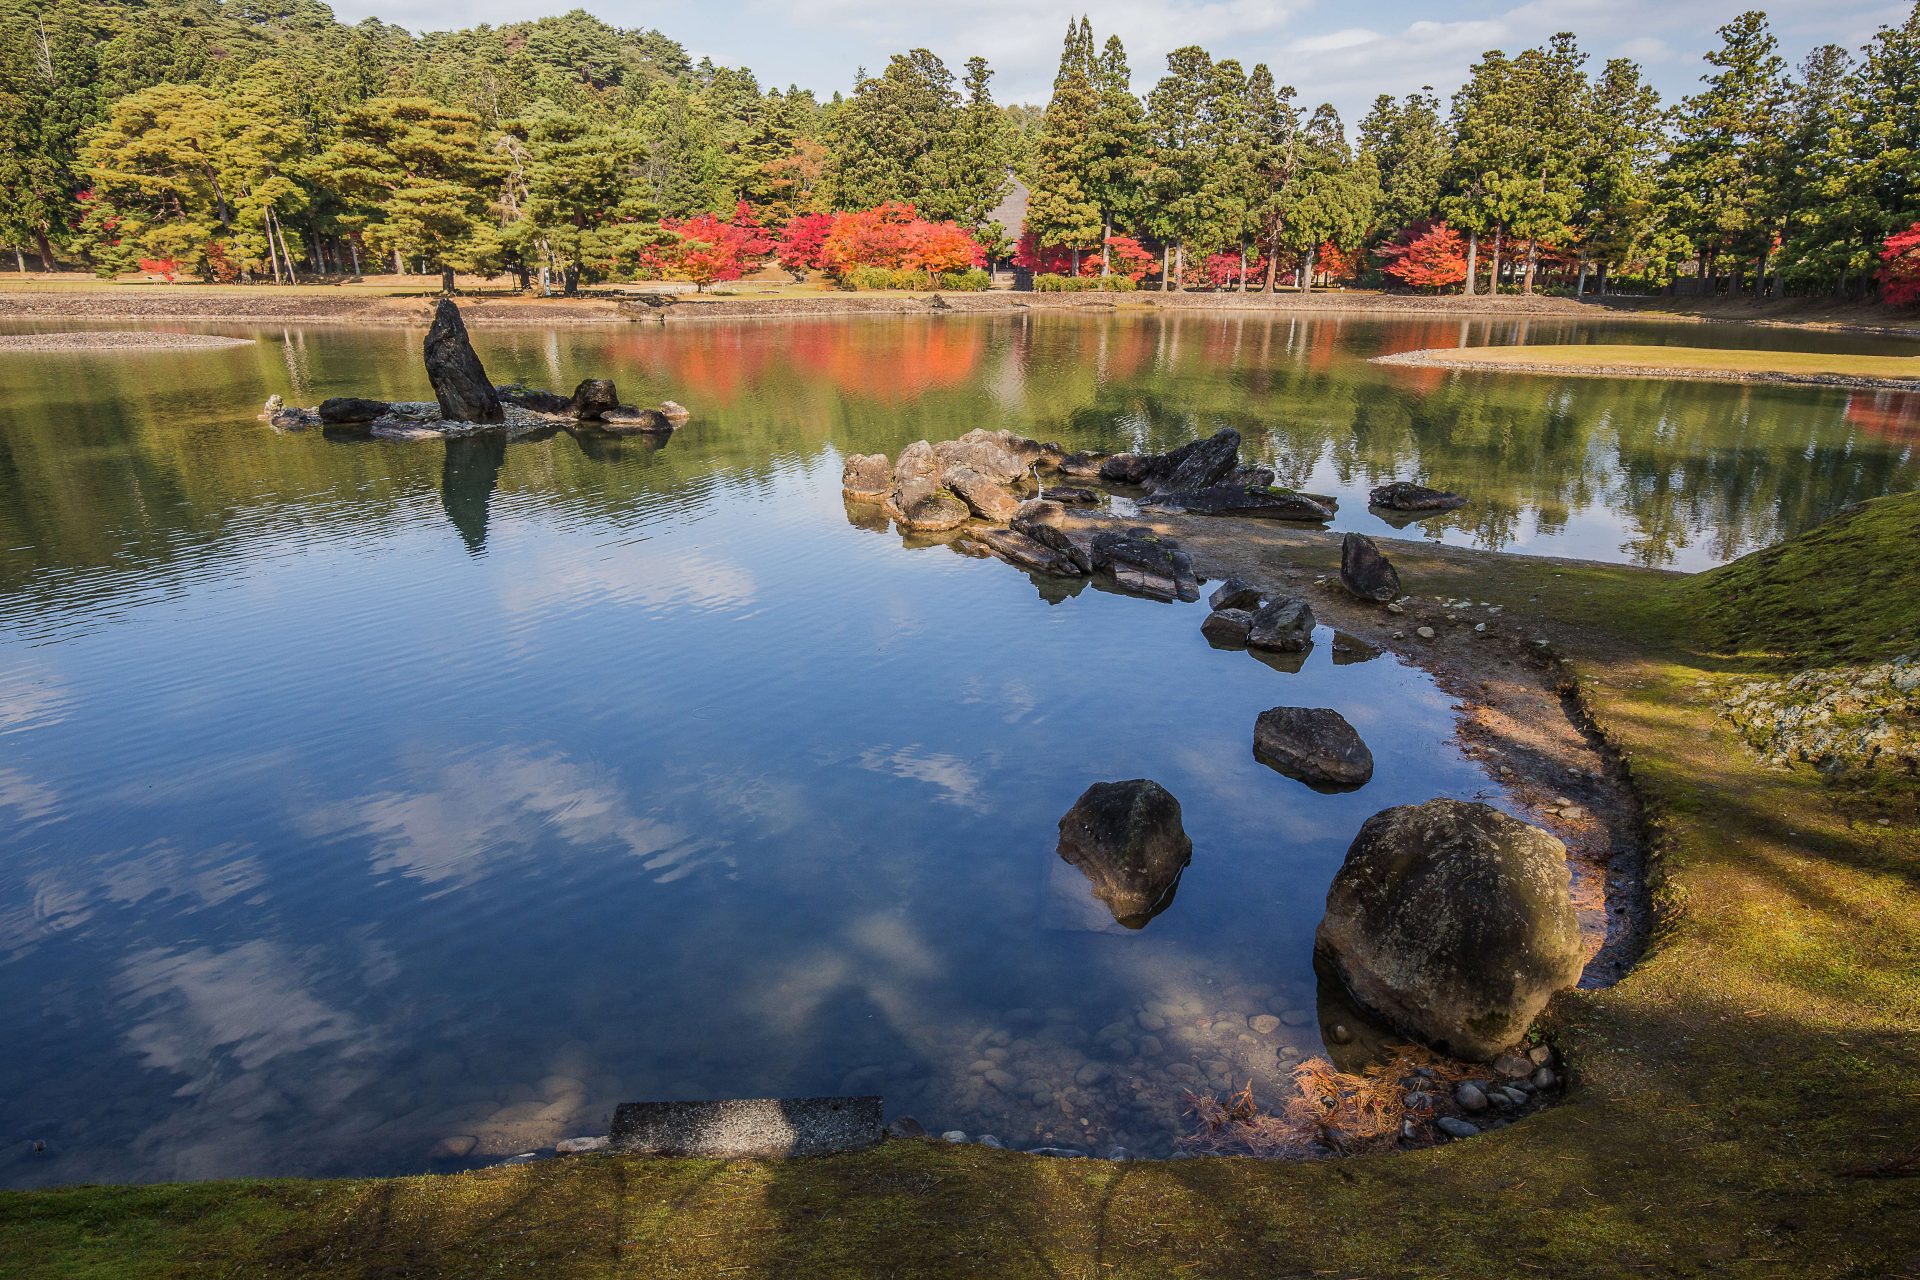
[261,297,687,439]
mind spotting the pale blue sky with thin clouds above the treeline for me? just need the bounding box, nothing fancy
[334,0,1910,121]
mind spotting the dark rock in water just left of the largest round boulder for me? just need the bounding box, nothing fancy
[1060,777,1194,929]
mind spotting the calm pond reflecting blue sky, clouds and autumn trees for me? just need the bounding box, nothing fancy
[0,305,1916,1186]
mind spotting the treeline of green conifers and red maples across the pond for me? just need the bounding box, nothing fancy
[11,0,1920,299]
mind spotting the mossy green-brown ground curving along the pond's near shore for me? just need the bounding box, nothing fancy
[0,495,1920,1280]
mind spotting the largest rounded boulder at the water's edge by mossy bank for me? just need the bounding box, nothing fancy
[1315,800,1580,1061]
